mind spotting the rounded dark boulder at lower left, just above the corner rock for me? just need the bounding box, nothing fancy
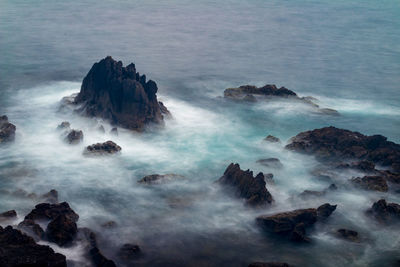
[46,214,78,246]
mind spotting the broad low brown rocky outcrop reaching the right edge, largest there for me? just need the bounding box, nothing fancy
[286,126,400,172]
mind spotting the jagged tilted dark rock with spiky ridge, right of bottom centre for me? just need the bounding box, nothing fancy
[218,163,273,206]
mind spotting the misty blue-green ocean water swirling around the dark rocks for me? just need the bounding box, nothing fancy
[0,0,400,266]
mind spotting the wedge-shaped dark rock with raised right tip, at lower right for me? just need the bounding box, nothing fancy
[256,203,336,242]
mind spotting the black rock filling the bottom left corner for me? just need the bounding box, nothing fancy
[0,226,67,267]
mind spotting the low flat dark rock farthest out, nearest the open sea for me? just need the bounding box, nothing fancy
[224,84,297,99]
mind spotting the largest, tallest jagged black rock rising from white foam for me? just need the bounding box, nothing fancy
[75,56,168,131]
